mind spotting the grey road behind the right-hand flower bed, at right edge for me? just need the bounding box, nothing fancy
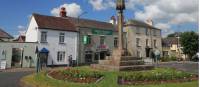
[159,62,199,74]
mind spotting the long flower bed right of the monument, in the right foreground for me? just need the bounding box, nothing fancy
[118,68,198,85]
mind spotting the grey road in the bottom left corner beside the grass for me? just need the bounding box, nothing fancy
[0,72,31,87]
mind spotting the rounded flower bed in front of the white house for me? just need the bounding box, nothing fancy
[48,68,103,83]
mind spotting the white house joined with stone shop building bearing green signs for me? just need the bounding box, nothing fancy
[26,8,115,66]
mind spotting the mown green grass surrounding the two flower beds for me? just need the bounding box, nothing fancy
[22,67,198,87]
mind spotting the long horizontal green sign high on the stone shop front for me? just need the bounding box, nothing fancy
[92,29,113,35]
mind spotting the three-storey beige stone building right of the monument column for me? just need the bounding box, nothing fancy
[125,20,162,61]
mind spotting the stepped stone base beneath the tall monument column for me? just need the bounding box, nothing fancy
[91,56,154,71]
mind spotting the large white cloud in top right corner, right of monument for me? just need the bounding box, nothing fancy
[135,0,198,24]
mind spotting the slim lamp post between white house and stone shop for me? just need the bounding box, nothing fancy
[77,11,87,66]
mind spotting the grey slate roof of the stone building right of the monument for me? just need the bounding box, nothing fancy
[125,20,160,30]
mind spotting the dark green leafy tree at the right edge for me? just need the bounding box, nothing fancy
[180,31,199,59]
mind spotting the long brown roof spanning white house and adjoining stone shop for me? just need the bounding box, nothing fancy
[33,13,115,31]
